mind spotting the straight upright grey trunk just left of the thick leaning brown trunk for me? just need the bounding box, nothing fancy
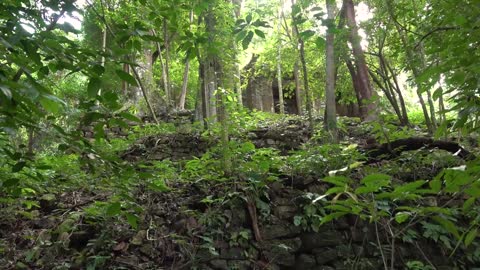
[325,0,338,142]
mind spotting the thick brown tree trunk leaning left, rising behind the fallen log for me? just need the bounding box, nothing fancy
[343,0,377,121]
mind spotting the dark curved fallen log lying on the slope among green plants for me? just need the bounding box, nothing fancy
[364,137,475,163]
